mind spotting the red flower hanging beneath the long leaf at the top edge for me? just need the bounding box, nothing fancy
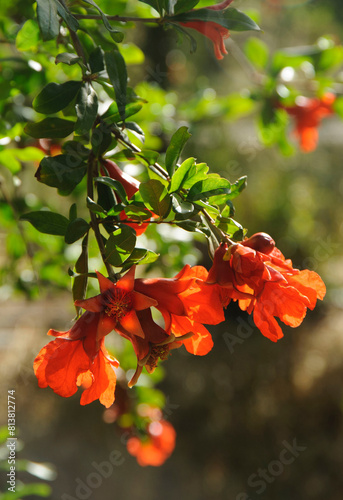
[180,0,233,60]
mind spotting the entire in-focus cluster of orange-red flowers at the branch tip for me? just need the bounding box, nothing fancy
[34,233,325,407]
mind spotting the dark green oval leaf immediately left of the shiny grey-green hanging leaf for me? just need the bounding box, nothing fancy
[32,80,82,114]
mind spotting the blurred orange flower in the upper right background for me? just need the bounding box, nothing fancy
[281,92,336,153]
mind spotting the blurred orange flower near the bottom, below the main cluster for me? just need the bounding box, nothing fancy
[126,420,176,467]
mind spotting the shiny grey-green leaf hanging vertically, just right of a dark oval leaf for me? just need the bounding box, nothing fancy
[75,83,98,135]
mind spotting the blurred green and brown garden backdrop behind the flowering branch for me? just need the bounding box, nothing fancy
[0,0,343,500]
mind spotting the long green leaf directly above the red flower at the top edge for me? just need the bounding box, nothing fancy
[170,8,261,31]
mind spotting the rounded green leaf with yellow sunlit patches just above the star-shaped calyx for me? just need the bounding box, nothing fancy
[105,224,136,267]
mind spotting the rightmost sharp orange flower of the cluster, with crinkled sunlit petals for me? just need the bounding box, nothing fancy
[208,233,326,342]
